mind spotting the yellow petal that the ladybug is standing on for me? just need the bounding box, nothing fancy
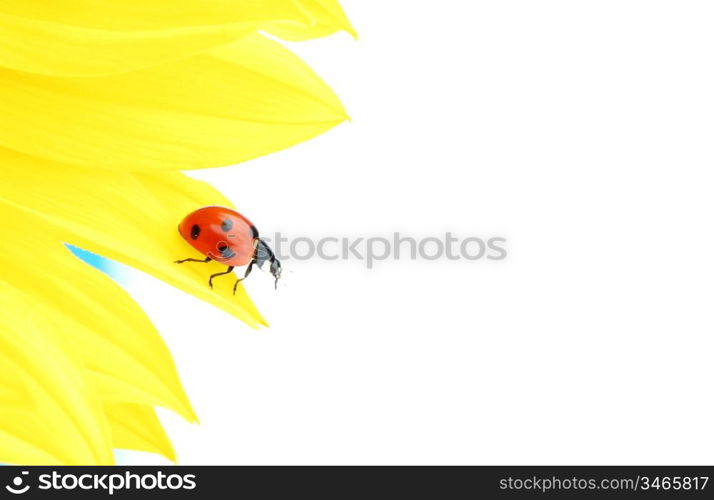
[0,149,266,328]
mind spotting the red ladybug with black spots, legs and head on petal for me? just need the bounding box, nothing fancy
[175,206,282,295]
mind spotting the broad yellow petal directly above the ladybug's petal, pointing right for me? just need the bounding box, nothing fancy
[0,35,346,171]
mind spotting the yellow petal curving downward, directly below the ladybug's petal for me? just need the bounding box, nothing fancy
[0,211,195,420]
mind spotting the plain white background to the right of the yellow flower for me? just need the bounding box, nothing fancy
[119,0,714,464]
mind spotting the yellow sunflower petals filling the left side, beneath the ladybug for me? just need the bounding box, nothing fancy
[0,0,354,464]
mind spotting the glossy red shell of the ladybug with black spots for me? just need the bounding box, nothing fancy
[179,207,258,266]
